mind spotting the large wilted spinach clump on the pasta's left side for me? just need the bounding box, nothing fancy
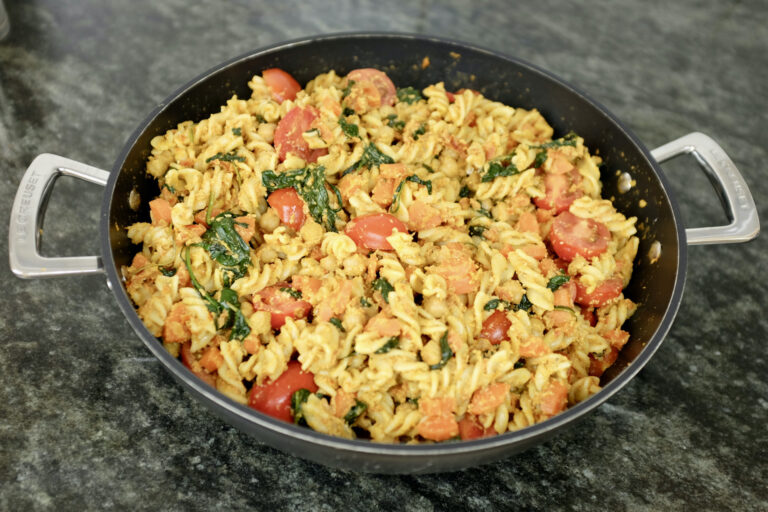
[200,212,251,286]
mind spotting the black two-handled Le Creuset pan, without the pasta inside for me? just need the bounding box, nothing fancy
[9,33,759,473]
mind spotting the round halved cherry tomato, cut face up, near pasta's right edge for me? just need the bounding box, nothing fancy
[549,211,611,261]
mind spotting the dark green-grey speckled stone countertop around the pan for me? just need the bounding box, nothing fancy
[0,0,768,510]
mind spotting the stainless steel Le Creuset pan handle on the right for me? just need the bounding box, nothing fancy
[651,132,760,245]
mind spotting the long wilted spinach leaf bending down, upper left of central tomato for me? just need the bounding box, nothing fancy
[261,165,341,231]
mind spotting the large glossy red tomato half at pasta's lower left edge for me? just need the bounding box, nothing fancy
[248,361,318,423]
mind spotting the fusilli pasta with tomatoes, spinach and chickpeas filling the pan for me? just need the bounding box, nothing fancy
[122,68,638,443]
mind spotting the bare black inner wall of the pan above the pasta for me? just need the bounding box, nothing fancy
[102,34,685,472]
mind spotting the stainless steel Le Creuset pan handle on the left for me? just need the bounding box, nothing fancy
[8,153,109,279]
